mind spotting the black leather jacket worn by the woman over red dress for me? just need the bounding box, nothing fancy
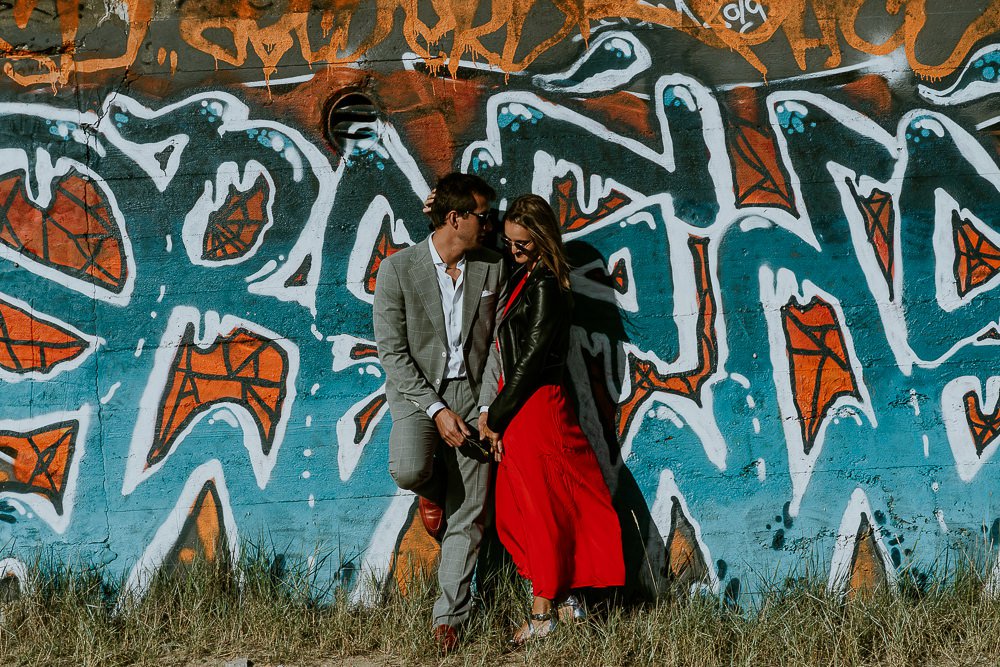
[486,266,573,433]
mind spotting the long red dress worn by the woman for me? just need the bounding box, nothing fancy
[496,278,625,602]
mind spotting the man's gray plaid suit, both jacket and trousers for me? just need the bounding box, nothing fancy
[374,241,506,626]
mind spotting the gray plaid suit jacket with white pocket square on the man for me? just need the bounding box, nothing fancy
[373,239,507,420]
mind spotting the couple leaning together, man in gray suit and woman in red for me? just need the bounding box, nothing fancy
[374,173,625,652]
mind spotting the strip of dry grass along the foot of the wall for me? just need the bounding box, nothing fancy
[0,549,1000,667]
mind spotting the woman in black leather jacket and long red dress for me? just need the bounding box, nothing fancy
[479,195,625,644]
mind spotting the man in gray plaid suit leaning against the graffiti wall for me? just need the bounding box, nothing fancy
[374,173,506,652]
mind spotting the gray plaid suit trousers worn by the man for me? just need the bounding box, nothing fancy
[389,379,490,627]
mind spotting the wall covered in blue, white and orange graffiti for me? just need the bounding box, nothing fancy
[0,0,1000,605]
